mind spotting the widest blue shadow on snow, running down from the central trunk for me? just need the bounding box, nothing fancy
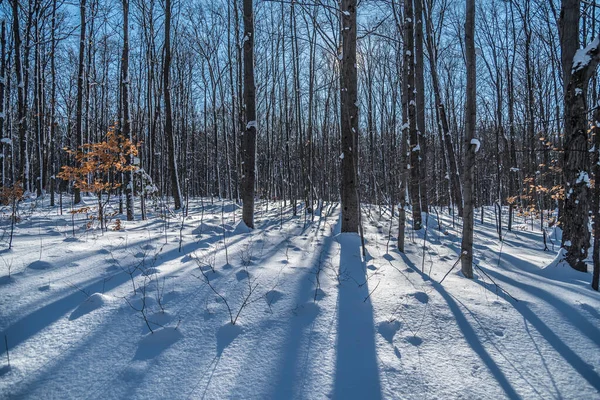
[333,233,382,399]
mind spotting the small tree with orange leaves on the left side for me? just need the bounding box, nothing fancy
[58,126,138,229]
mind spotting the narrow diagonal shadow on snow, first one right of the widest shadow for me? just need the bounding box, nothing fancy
[403,257,520,399]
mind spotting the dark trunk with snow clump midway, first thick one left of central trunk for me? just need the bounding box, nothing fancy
[241,0,257,228]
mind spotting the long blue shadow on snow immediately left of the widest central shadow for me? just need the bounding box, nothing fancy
[270,214,340,399]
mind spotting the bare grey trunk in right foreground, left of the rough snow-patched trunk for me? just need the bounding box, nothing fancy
[461,0,477,279]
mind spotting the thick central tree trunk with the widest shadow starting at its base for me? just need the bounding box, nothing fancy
[340,0,360,232]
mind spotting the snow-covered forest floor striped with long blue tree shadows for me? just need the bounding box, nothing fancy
[0,198,600,399]
